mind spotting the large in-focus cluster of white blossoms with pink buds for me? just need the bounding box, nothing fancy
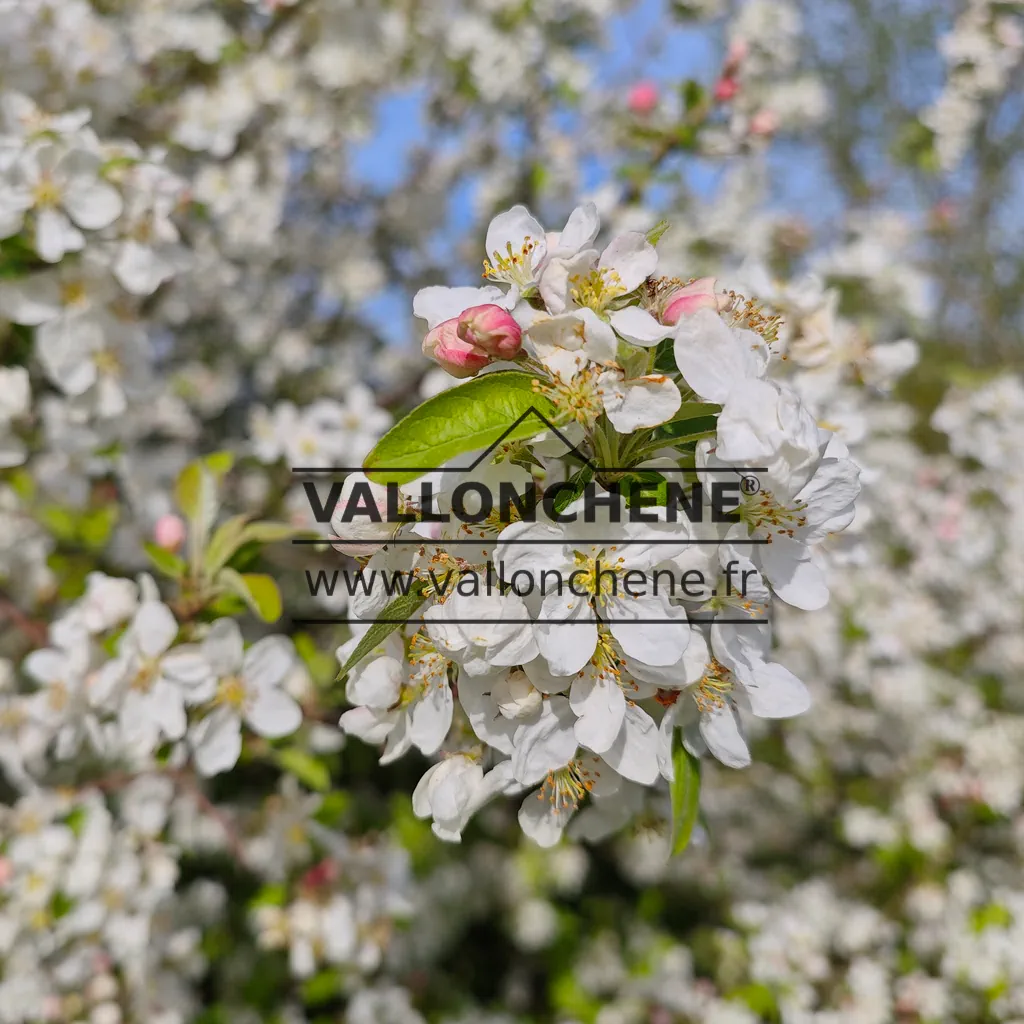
[333,205,859,846]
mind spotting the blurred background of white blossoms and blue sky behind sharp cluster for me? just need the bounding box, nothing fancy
[0,0,1024,1024]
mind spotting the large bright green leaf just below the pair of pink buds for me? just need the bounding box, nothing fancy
[364,370,556,483]
